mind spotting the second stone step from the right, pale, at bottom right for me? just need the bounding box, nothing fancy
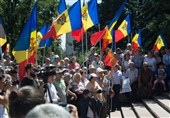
[142,99,170,118]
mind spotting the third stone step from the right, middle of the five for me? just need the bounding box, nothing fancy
[132,103,154,118]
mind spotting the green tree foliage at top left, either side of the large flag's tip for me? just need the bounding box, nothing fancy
[0,0,58,51]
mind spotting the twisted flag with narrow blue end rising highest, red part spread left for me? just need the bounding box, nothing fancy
[90,2,126,49]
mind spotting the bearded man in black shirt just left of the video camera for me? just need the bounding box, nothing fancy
[21,64,38,87]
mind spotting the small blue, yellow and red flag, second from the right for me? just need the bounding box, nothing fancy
[132,30,142,52]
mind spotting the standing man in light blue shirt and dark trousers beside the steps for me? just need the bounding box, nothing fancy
[111,64,122,111]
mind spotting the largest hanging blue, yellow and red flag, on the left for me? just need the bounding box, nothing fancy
[12,3,37,80]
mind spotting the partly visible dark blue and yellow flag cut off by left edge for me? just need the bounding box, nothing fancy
[0,18,7,47]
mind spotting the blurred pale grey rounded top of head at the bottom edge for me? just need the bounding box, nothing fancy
[25,104,72,118]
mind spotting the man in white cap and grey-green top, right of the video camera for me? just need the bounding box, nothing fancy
[53,70,67,104]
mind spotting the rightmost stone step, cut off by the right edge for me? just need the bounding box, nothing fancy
[154,96,170,113]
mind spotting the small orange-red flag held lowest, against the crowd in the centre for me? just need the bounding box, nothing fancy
[104,49,118,67]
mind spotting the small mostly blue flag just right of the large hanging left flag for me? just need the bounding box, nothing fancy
[37,25,52,47]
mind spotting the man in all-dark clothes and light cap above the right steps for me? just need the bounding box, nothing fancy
[138,62,153,98]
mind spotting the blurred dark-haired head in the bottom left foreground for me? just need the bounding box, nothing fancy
[9,86,45,118]
